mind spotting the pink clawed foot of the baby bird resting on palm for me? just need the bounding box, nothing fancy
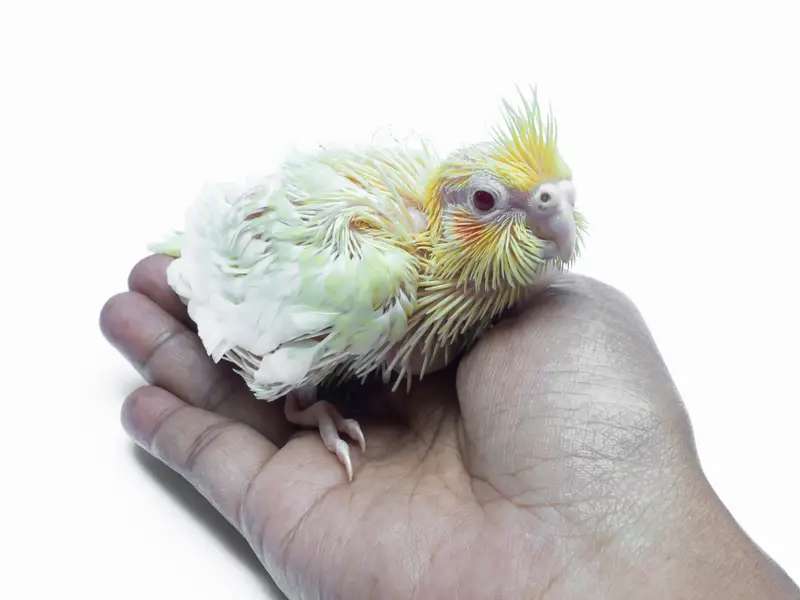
[284,393,366,481]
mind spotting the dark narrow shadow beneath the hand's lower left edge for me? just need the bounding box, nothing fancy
[133,446,286,599]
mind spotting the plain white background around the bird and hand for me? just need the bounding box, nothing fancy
[0,0,800,600]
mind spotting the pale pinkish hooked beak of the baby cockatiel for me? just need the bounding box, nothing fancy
[528,181,578,262]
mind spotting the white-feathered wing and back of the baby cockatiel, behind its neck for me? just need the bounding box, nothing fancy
[168,143,435,400]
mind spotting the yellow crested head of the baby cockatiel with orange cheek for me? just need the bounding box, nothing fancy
[426,90,585,289]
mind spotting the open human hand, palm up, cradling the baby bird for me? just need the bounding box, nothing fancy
[101,256,800,600]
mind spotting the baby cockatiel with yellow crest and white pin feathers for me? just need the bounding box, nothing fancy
[153,92,584,480]
